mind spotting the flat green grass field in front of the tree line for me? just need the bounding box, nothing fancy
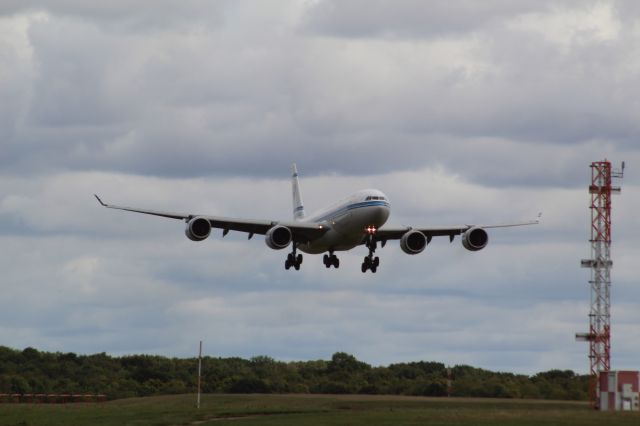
[0,395,640,426]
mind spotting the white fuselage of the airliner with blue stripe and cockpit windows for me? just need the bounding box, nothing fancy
[298,189,391,254]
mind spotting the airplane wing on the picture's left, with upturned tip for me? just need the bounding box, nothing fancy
[94,194,327,242]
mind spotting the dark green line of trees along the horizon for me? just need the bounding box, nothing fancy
[0,346,588,400]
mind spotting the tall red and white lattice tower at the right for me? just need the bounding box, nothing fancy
[576,160,624,408]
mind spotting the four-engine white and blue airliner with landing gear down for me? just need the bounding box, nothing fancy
[94,163,541,273]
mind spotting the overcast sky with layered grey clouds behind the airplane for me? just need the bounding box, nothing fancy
[0,0,640,374]
